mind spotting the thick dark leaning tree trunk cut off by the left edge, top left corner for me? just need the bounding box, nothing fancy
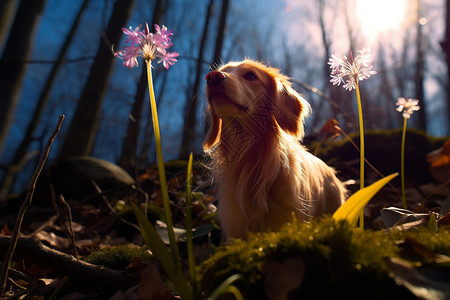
[0,0,45,154]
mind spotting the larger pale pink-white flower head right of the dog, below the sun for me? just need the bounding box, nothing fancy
[328,48,377,91]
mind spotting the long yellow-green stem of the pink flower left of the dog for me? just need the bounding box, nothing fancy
[145,60,181,271]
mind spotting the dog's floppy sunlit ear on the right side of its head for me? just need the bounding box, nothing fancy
[274,79,310,138]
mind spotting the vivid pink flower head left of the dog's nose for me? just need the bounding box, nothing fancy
[114,23,179,69]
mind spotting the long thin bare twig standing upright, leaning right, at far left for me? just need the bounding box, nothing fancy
[0,115,65,296]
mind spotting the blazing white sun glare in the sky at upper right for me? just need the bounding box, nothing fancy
[355,0,407,39]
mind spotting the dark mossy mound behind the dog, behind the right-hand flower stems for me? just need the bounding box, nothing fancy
[308,128,448,185]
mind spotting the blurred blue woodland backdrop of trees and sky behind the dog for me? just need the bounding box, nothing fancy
[0,0,450,197]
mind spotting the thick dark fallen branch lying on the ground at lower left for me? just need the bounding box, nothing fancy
[0,237,138,289]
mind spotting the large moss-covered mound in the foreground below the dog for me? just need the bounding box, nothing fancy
[199,217,450,299]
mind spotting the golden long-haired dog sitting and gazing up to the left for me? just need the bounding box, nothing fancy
[203,60,346,239]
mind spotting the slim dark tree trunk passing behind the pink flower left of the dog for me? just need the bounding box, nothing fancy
[119,0,167,174]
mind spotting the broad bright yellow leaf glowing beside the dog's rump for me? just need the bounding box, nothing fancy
[333,173,398,225]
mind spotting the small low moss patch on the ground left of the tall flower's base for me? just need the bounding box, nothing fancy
[84,245,154,270]
